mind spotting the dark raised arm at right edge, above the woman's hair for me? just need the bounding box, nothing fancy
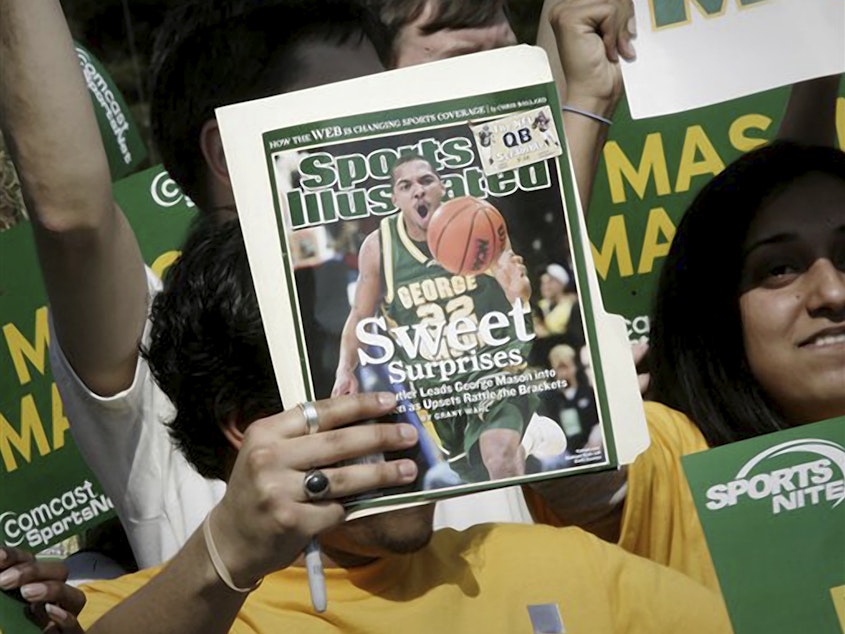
[778,75,845,146]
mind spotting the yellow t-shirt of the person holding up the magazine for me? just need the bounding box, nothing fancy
[80,524,730,634]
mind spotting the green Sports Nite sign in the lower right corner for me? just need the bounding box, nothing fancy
[683,418,845,634]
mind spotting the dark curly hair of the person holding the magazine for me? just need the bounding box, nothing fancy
[141,216,283,480]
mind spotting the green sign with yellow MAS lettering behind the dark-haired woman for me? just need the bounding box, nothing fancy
[588,87,845,341]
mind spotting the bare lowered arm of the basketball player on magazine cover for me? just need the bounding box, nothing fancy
[332,230,381,396]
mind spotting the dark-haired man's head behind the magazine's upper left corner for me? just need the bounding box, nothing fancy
[150,0,386,212]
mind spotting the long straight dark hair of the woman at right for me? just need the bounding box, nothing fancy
[649,141,845,446]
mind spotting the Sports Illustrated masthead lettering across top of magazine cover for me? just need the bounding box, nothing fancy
[278,136,552,230]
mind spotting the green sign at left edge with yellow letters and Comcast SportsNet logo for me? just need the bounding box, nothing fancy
[0,223,111,551]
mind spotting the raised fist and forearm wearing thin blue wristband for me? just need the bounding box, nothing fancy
[538,0,634,213]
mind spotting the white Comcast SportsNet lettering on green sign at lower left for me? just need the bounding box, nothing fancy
[0,480,114,548]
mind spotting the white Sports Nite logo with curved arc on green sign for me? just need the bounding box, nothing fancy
[706,438,845,515]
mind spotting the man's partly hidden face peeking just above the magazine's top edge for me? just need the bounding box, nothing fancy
[363,0,516,67]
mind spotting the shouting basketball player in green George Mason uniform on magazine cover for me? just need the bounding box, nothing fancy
[332,155,552,481]
